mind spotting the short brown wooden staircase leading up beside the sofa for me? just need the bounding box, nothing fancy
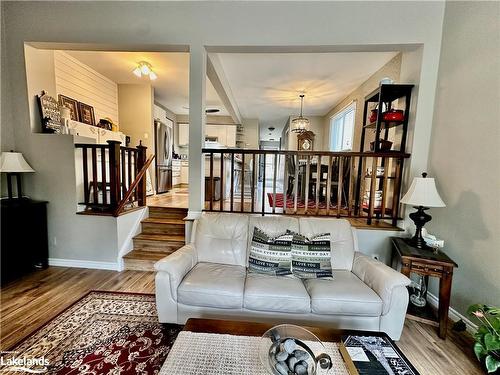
[123,206,188,271]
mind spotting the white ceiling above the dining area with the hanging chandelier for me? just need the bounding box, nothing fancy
[218,52,397,140]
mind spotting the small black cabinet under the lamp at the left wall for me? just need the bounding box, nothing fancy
[0,198,48,285]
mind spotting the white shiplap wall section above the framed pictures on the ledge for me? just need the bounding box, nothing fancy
[54,51,118,122]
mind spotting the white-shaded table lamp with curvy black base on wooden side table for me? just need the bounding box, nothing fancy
[401,172,446,249]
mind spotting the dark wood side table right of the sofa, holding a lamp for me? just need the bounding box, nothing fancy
[391,237,458,339]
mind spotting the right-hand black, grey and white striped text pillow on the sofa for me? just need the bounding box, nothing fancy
[292,233,333,279]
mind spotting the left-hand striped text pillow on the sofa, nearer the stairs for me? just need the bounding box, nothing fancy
[248,227,293,276]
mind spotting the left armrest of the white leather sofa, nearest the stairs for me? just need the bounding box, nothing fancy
[155,243,198,301]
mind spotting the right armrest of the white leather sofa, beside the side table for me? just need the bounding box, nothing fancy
[352,252,410,315]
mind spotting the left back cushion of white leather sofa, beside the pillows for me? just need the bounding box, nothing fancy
[193,213,248,266]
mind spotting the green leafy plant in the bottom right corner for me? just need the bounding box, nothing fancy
[467,304,500,373]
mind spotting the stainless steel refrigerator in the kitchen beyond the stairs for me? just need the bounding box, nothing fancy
[155,121,174,194]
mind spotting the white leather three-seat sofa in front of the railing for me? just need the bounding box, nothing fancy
[155,213,410,340]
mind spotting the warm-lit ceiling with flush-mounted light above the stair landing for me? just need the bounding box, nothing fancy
[65,51,229,115]
